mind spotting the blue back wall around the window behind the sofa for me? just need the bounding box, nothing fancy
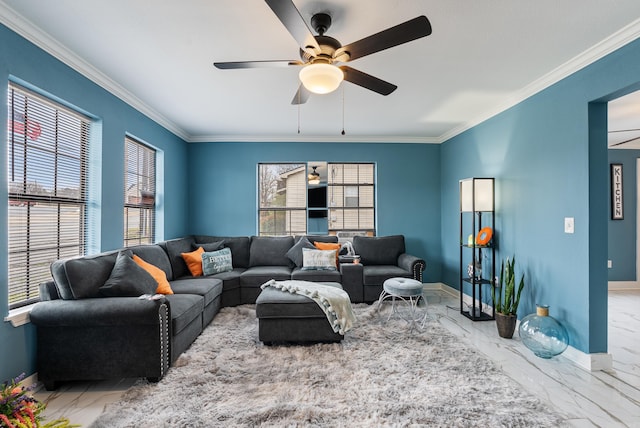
[189,143,440,282]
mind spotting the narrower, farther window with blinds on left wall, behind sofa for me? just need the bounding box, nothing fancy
[124,137,156,247]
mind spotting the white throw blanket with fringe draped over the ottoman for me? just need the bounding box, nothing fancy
[260,279,356,335]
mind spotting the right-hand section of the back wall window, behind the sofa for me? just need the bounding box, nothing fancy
[328,163,375,235]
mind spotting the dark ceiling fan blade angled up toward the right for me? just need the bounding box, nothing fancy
[336,15,431,61]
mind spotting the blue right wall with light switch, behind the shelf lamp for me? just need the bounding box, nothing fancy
[441,40,640,353]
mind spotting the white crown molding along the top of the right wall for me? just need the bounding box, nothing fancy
[437,19,640,143]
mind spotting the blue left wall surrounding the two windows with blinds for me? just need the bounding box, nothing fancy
[0,25,188,382]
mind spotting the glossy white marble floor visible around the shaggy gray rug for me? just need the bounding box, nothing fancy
[36,290,640,428]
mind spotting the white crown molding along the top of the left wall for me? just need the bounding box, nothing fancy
[0,2,190,140]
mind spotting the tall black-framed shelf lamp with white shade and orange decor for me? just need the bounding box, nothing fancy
[459,178,496,321]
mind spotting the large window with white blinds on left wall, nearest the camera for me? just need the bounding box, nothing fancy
[7,83,91,309]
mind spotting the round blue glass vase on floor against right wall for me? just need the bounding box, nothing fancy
[518,305,569,358]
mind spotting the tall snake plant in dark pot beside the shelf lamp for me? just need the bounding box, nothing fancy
[493,256,524,339]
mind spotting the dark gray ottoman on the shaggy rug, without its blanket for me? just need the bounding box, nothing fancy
[256,282,344,345]
